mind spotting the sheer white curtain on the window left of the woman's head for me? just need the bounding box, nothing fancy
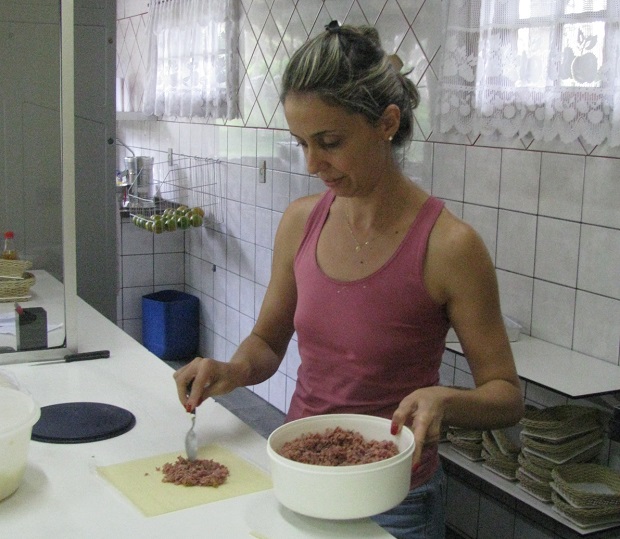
[143,0,239,119]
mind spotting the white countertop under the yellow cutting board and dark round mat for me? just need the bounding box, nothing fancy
[0,301,392,539]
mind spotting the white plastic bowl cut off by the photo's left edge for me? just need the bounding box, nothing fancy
[0,387,41,501]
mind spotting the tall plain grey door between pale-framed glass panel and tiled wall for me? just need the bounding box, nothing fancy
[75,0,118,322]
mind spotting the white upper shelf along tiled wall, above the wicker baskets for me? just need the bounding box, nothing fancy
[446,335,620,398]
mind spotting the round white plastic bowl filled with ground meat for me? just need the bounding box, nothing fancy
[267,414,415,520]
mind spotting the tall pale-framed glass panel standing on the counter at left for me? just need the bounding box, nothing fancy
[0,0,77,364]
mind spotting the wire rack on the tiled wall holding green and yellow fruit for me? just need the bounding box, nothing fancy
[129,156,224,229]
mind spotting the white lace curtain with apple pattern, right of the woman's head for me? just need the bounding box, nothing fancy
[435,0,620,146]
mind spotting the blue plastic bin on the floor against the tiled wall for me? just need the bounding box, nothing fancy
[142,290,200,361]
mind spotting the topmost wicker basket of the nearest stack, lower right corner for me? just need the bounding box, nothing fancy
[551,463,620,513]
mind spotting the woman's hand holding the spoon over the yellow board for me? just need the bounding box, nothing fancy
[173,357,237,412]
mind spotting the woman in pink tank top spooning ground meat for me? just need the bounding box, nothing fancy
[175,23,523,539]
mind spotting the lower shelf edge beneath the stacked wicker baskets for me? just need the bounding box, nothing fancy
[439,443,620,536]
